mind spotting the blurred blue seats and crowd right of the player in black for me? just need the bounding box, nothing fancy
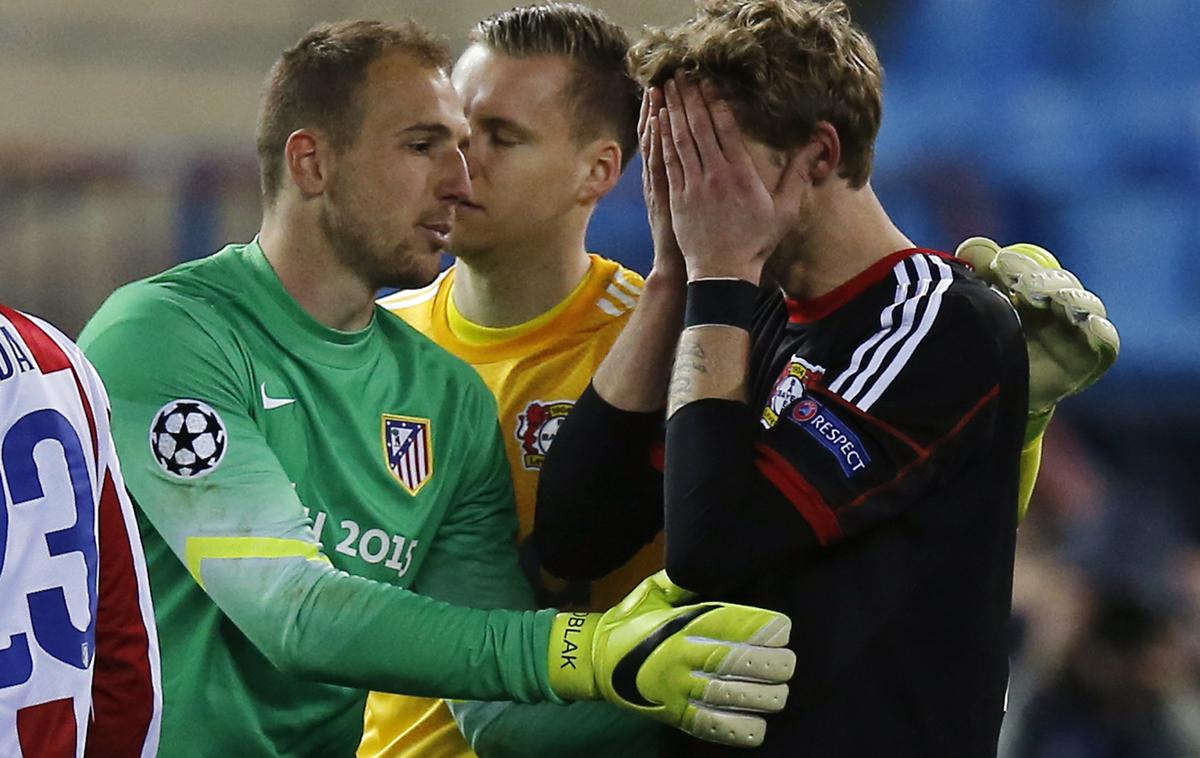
[854,0,1200,758]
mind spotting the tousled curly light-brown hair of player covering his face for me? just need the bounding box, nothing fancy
[630,0,883,187]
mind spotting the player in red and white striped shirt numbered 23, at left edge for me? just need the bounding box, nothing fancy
[0,305,162,758]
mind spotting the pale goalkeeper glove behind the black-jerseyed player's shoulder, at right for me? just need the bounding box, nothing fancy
[955,237,1121,441]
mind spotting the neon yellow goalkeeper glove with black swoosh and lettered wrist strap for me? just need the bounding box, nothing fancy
[550,571,796,747]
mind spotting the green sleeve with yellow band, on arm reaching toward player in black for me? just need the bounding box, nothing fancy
[80,288,557,702]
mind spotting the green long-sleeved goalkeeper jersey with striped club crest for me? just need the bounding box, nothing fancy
[79,241,557,756]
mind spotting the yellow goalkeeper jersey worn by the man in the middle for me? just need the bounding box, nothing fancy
[359,255,662,758]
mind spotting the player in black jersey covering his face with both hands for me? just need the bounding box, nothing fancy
[535,0,1111,758]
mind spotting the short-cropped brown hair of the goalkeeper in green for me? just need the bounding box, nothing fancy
[256,20,450,205]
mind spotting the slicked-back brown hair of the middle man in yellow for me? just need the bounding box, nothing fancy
[470,2,642,168]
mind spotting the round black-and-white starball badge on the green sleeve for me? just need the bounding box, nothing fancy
[150,399,229,479]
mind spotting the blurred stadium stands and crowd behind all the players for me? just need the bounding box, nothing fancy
[0,0,1200,758]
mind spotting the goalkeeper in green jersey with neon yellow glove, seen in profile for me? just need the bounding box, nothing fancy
[79,22,794,756]
